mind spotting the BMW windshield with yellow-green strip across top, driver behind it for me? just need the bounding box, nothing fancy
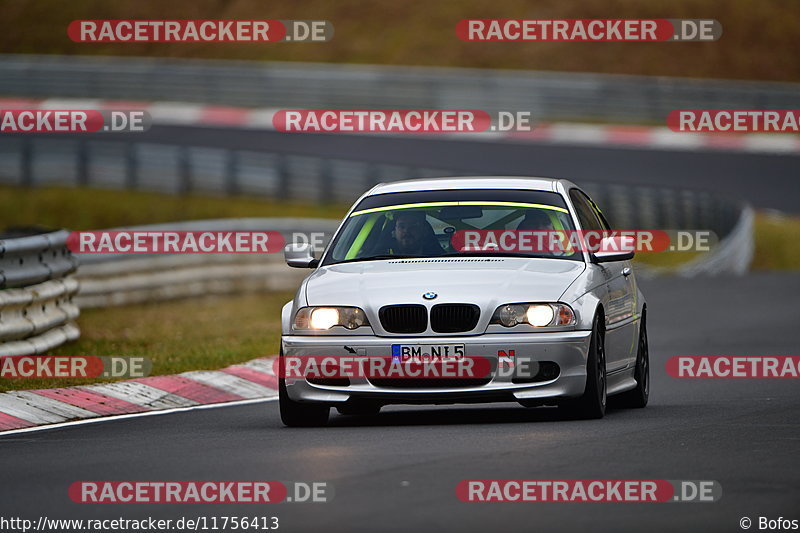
[323,189,583,265]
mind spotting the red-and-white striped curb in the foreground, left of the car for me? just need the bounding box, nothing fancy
[0,357,278,435]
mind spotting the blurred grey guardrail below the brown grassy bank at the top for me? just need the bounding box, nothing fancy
[0,54,800,122]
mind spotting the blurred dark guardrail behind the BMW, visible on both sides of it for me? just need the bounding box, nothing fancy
[0,137,740,235]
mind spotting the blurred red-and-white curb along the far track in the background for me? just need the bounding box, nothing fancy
[0,98,800,153]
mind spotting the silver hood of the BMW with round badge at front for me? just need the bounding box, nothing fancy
[306,258,585,314]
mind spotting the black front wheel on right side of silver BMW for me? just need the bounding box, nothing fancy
[559,314,608,420]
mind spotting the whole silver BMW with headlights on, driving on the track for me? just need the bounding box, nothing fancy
[277,177,649,426]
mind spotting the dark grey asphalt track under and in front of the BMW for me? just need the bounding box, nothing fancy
[0,274,800,533]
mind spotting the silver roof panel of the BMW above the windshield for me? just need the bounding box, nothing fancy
[367,176,559,196]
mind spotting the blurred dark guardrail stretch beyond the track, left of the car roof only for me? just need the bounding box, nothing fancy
[0,136,444,203]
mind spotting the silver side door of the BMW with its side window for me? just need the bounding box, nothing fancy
[570,189,636,373]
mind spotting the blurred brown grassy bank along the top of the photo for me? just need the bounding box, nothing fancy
[0,0,800,81]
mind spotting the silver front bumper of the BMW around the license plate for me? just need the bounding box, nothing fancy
[282,331,591,405]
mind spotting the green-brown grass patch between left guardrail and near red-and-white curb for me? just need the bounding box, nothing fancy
[0,292,294,391]
